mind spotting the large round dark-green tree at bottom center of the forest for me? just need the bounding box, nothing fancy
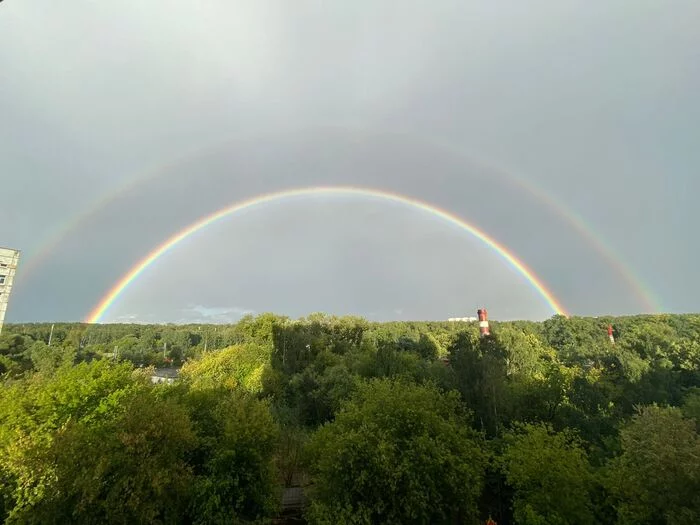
[307,379,485,523]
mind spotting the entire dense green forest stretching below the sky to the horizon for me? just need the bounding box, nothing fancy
[0,314,700,525]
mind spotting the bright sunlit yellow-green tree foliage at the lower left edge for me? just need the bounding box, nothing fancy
[0,362,148,521]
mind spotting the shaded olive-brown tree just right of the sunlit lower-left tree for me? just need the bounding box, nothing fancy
[23,388,194,524]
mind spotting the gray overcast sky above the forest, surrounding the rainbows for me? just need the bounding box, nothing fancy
[0,0,700,322]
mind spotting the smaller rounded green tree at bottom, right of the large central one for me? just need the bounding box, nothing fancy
[500,424,595,525]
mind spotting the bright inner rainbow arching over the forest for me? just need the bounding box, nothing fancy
[86,186,568,323]
